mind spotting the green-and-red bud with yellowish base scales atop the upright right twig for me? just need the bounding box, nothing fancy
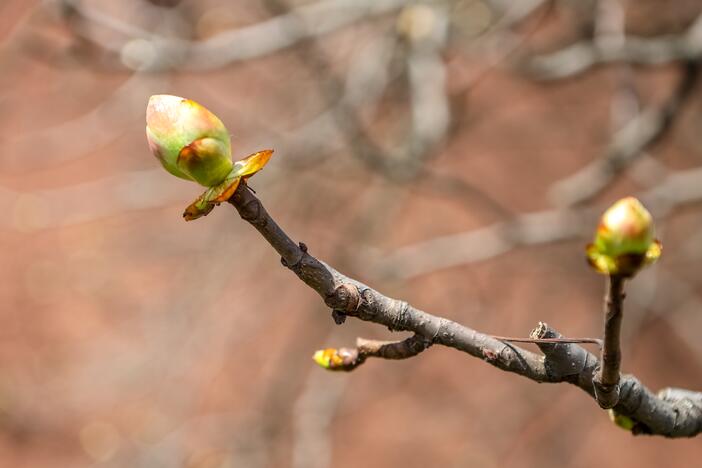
[587,197,661,277]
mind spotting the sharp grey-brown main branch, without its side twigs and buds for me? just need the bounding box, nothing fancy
[229,184,702,437]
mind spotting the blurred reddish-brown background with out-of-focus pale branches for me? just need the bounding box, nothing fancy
[0,0,702,468]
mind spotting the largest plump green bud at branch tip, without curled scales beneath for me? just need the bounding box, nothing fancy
[146,94,233,187]
